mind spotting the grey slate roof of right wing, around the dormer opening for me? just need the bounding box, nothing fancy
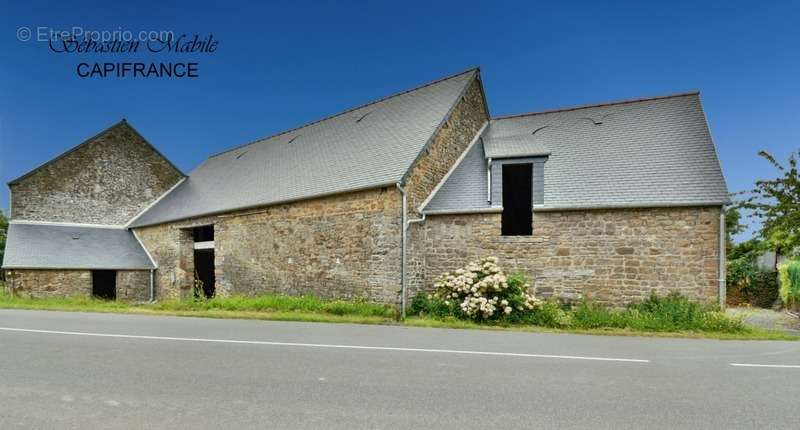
[425,92,730,211]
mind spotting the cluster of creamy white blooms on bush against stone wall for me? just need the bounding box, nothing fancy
[433,257,540,318]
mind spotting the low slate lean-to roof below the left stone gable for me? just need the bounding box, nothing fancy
[3,222,155,270]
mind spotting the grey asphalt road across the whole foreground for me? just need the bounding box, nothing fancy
[0,310,800,429]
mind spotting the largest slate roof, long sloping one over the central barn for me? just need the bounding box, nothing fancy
[130,69,478,227]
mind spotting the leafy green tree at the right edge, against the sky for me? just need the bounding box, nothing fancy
[737,151,800,255]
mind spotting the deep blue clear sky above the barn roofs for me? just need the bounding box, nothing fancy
[0,1,800,239]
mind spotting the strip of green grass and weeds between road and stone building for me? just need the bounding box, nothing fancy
[0,289,798,340]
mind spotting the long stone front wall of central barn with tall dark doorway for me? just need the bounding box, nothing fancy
[136,188,400,303]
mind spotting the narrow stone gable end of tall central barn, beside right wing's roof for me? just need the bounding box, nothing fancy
[406,79,489,297]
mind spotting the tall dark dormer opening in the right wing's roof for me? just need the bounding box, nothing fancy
[501,164,533,236]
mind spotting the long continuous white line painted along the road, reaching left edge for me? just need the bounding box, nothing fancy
[0,327,650,363]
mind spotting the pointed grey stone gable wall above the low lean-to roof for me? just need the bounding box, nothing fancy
[9,122,181,225]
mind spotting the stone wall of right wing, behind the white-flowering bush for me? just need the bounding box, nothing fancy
[418,207,720,306]
